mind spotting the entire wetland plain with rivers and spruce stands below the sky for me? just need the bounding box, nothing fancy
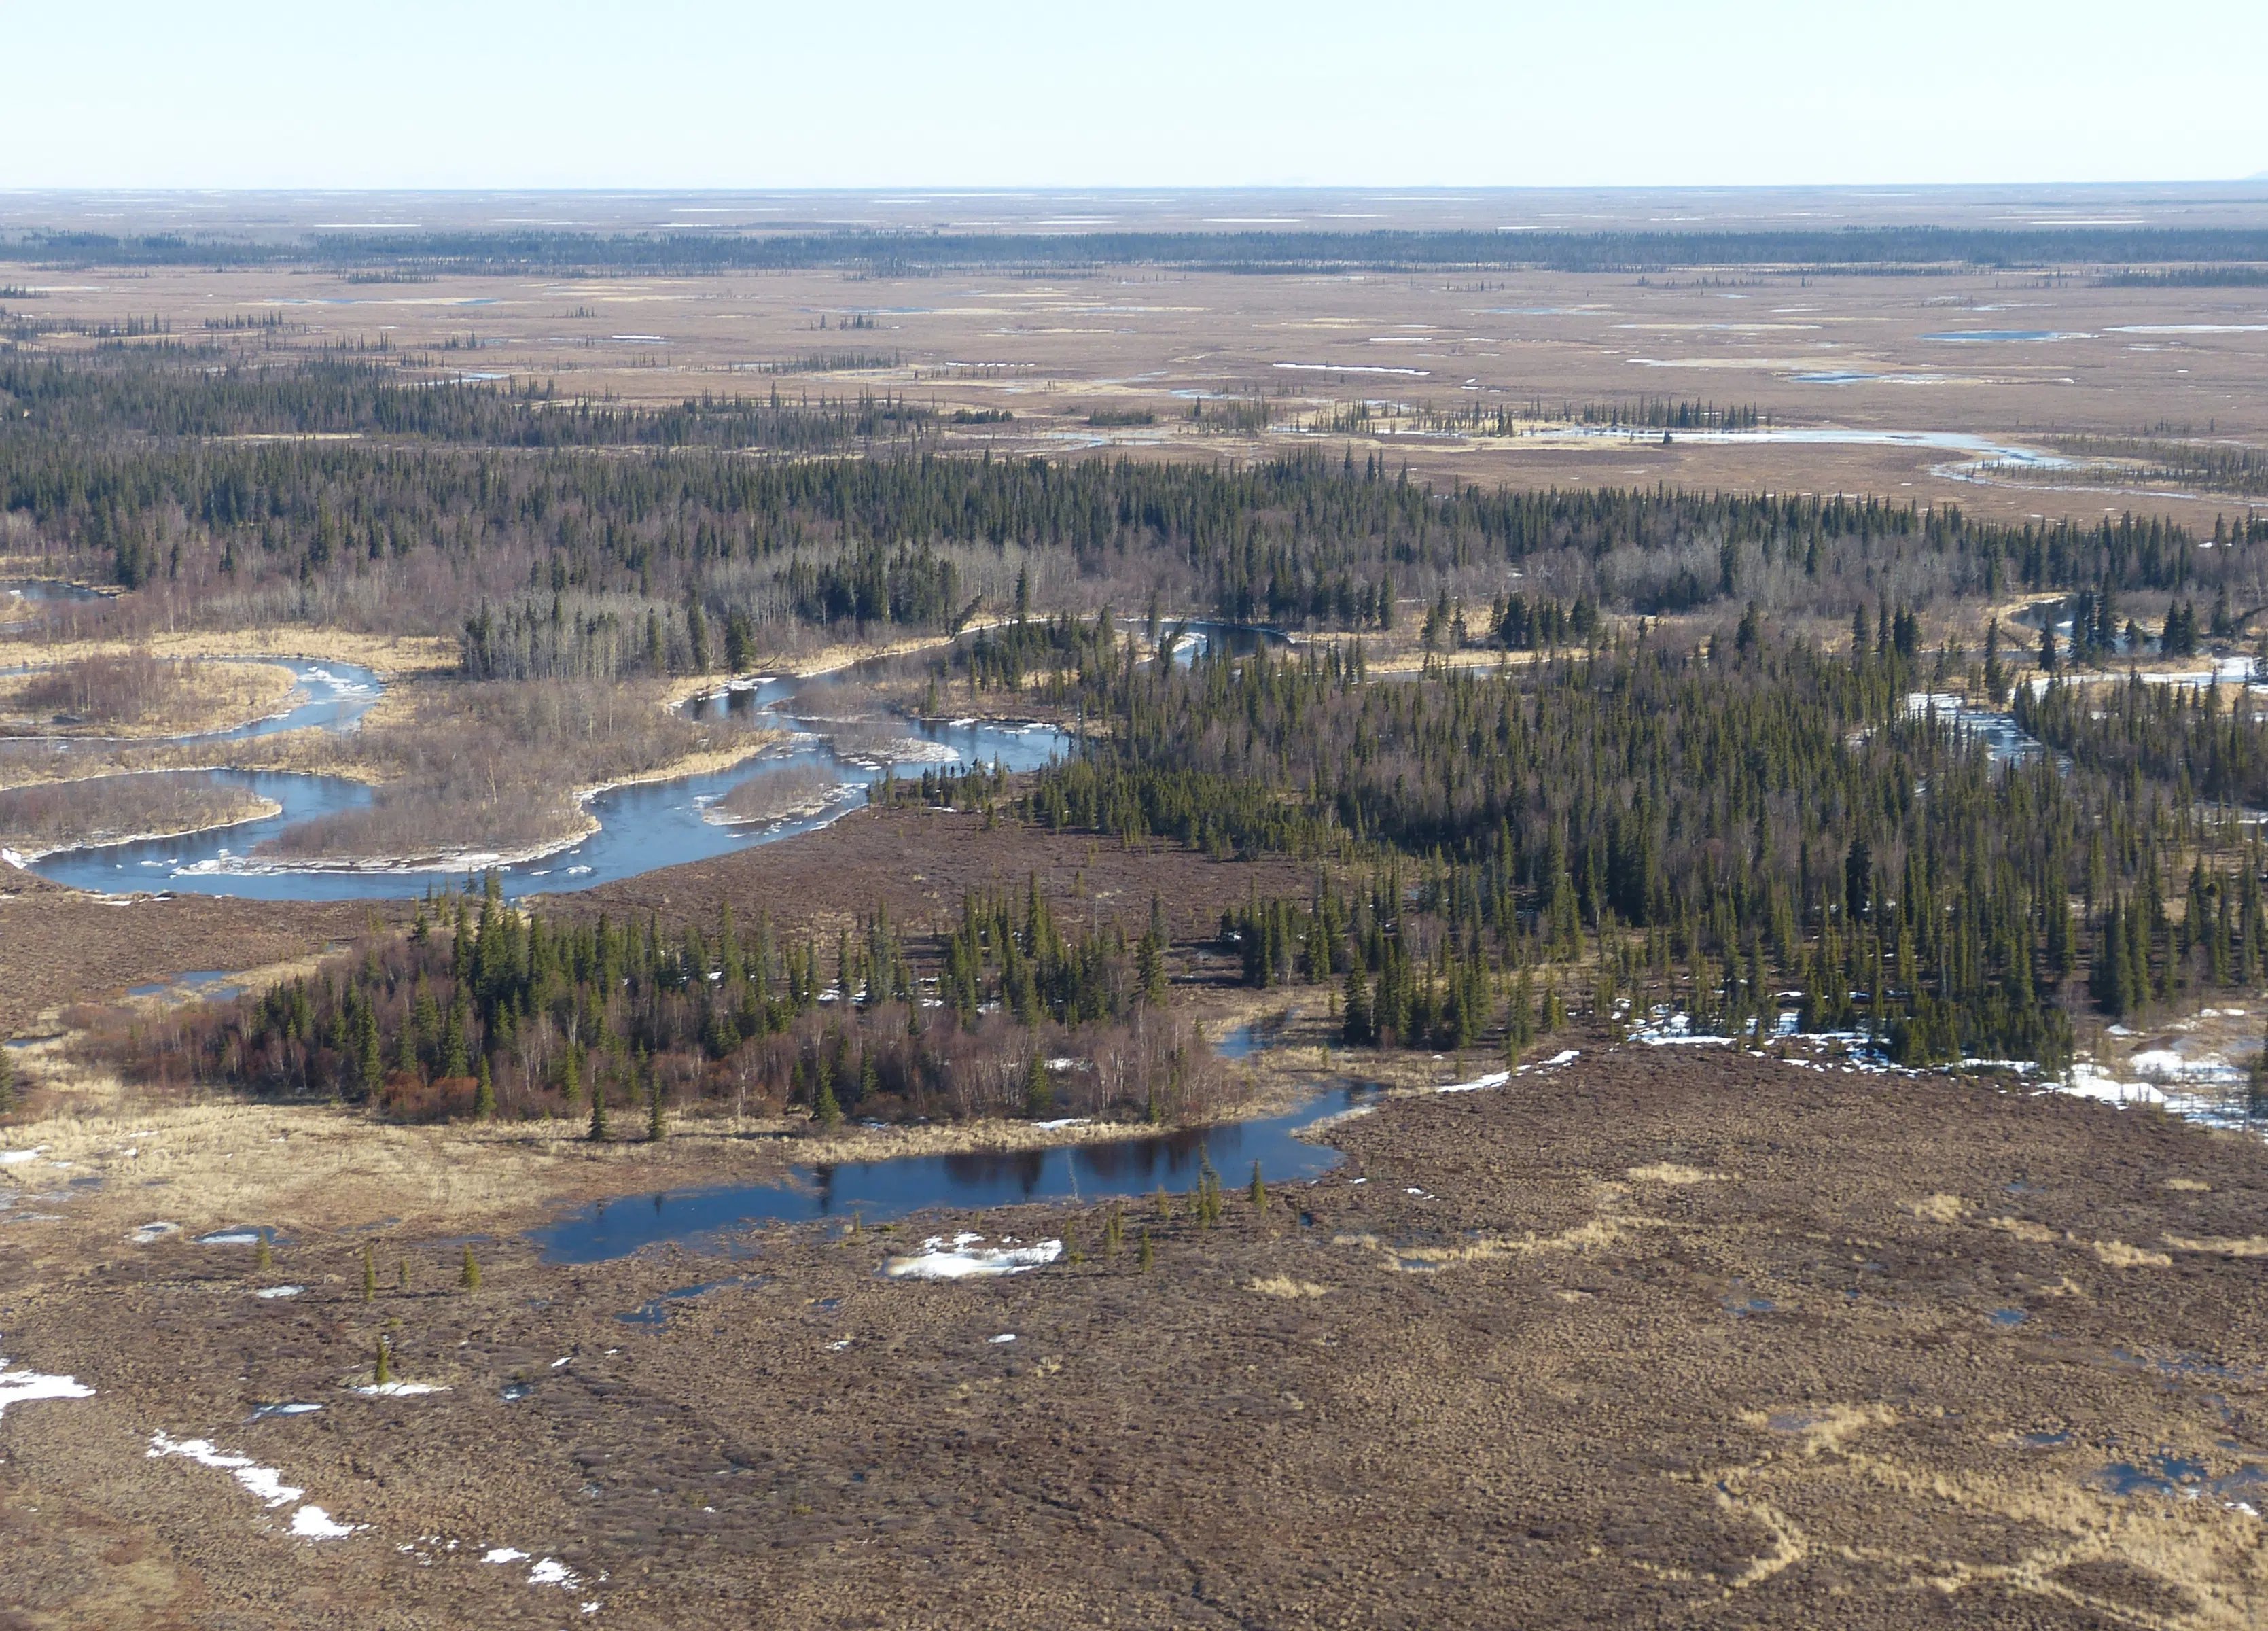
[0,190,2268,1631]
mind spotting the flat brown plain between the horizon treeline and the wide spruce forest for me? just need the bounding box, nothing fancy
[0,263,2268,531]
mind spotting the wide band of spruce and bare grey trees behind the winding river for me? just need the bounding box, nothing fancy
[0,356,2268,639]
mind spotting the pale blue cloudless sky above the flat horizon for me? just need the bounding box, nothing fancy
[0,0,2268,188]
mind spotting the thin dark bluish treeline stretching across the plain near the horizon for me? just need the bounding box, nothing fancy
[13,227,2268,277]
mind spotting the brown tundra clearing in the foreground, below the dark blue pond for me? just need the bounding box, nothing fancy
[0,1043,2268,1626]
